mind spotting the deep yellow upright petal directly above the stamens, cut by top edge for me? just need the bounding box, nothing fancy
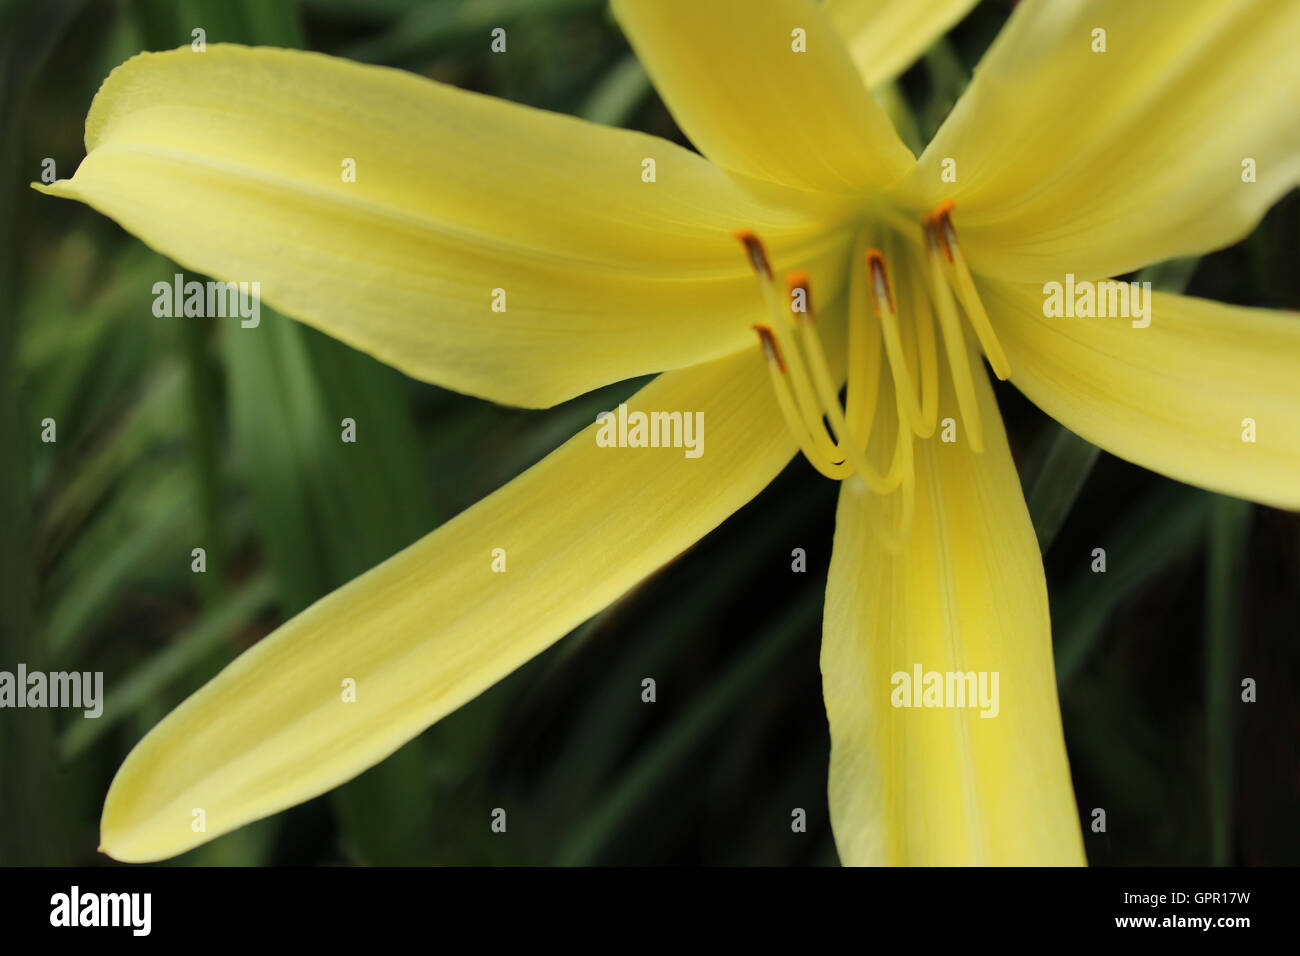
[614,0,913,194]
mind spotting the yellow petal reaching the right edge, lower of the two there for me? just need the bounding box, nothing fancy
[980,282,1300,509]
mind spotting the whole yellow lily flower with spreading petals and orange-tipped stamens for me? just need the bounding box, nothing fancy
[38,0,1300,864]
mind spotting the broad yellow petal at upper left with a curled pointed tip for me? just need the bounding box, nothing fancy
[38,46,832,406]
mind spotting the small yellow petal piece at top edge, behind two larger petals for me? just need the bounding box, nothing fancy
[823,0,975,87]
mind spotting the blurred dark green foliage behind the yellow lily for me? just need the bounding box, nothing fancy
[0,0,1300,864]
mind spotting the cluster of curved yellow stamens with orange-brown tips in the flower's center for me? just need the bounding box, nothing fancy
[736,202,1010,549]
